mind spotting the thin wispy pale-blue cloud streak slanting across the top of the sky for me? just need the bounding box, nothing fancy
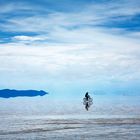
[0,0,140,35]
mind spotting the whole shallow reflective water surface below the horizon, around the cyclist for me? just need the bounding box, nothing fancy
[0,97,140,140]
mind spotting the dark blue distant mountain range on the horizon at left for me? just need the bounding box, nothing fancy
[0,89,48,98]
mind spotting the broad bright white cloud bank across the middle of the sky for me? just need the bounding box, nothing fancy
[0,35,140,82]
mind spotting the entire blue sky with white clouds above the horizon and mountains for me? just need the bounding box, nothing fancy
[0,0,140,98]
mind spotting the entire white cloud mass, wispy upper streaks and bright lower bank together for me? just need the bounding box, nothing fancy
[0,2,140,90]
